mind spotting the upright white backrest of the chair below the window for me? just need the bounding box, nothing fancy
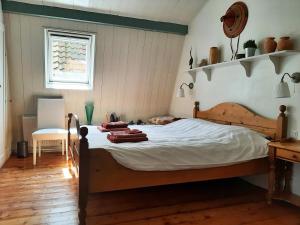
[37,98,65,129]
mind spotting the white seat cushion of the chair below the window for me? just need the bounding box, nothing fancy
[32,128,68,140]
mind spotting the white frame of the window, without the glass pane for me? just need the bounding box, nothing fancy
[44,28,96,90]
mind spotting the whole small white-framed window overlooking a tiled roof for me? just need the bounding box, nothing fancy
[45,29,95,90]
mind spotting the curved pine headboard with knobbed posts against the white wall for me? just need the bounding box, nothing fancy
[193,102,287,140]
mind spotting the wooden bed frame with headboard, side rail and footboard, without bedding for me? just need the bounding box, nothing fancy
[68,102,287,225]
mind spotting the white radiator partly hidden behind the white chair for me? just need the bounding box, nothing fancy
[22,115,61,152]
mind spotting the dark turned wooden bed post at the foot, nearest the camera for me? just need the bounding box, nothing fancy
[78,127,89,225]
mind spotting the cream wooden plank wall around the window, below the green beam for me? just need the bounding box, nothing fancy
[4,13,184,148]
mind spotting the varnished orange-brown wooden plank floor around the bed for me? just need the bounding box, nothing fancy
[0,153,300,225]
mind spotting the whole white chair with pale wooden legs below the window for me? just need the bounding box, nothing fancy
[32,98,68,165]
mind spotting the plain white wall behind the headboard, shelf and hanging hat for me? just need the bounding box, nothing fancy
[170,0,300,194]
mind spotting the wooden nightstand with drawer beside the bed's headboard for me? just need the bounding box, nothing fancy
[268,141,300,206]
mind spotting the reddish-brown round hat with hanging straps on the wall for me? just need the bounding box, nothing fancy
[220,2,248,60]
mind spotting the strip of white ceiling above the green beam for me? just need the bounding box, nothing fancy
[9,0,206,24]
